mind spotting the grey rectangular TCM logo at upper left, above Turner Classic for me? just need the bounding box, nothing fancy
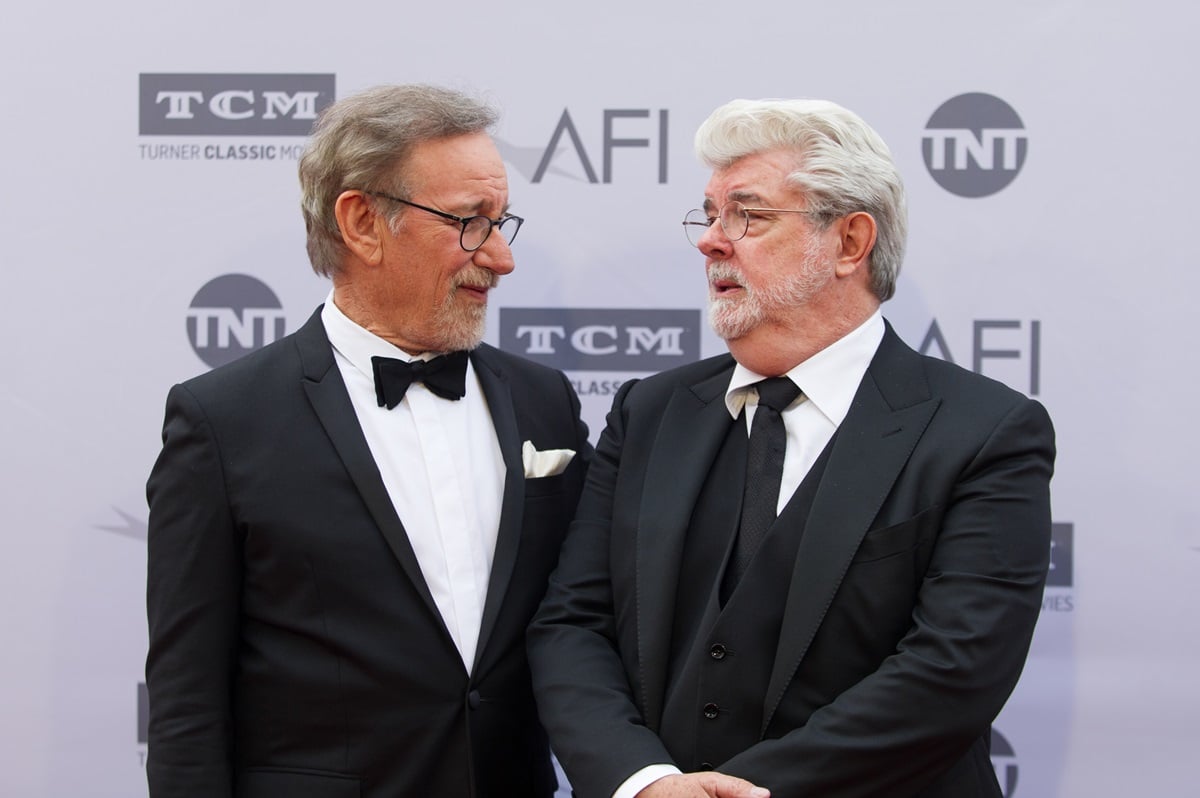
[138,74,335,136]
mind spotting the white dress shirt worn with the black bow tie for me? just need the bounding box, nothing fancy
[320,293,504,673]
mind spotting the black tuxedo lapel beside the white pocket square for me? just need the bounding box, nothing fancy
[470,347,524,673]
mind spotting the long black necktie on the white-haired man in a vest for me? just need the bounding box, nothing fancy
[722,377,800,599]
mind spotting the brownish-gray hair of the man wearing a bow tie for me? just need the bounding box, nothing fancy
[300,84,498,277]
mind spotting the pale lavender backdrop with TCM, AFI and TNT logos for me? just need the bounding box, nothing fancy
[0,0,1200,798]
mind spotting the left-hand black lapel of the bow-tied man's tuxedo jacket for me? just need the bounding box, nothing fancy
[295,308,449,636]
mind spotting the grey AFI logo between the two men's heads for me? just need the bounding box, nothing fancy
[496,108,670,184]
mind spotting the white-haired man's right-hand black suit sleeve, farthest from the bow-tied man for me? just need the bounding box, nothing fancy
[720,400,1054,798]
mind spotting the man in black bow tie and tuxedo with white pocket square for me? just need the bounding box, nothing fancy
[146,85,592,798]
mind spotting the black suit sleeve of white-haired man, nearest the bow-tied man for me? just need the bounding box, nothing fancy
[529,380,672,798]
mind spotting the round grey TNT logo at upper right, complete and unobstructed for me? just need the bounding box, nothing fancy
[920,92,1028,197]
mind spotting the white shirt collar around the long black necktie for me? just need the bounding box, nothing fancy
[725,310,883,426]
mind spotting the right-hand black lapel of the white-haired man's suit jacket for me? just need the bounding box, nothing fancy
[762,325,941,731]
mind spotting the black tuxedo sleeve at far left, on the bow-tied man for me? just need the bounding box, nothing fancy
[146,385,241,798]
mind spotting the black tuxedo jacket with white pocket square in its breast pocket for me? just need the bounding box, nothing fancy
[146,310,592,798]
